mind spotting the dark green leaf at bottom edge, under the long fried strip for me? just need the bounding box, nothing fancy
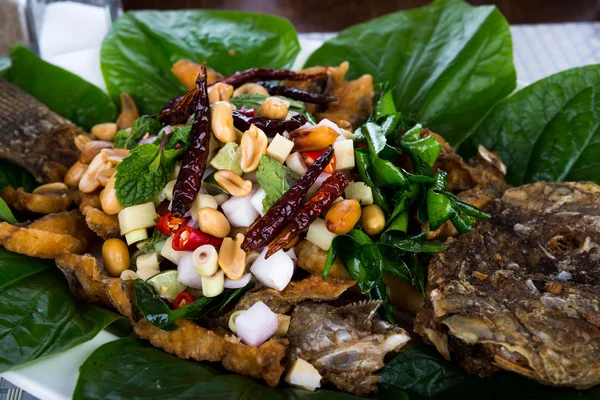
[73,339,359,400]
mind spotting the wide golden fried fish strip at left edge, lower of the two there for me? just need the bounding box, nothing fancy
[0,210,89,258]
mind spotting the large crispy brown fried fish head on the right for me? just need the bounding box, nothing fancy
[415,182,600,389]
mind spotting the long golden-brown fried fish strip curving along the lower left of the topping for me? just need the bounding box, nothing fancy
[57,254,285,387]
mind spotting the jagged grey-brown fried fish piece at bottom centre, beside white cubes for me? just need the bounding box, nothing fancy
[288,301,410,396]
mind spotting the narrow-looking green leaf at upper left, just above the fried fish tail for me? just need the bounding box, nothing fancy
[7,45,117,131]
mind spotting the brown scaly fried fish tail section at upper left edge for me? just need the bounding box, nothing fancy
[0,78,85,183]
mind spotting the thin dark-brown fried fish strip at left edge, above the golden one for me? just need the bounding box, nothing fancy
[0,186,79,214]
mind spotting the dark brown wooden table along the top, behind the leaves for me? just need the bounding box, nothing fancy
[123,0,600,32]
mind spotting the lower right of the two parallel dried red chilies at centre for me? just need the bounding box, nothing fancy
[265,172,350,258]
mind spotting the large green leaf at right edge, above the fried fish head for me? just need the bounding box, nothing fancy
[461,65,600,185]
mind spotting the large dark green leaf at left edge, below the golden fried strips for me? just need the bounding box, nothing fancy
[0,248,122,373]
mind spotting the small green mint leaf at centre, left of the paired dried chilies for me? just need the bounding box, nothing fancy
[256,155,300,212]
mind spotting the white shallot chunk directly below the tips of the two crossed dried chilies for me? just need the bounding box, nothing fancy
[250,247,294,292]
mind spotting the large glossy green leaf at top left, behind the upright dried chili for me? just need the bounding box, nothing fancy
[101,10,300,114]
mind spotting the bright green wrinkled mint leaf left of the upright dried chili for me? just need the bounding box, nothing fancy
[115,144,175,207]
